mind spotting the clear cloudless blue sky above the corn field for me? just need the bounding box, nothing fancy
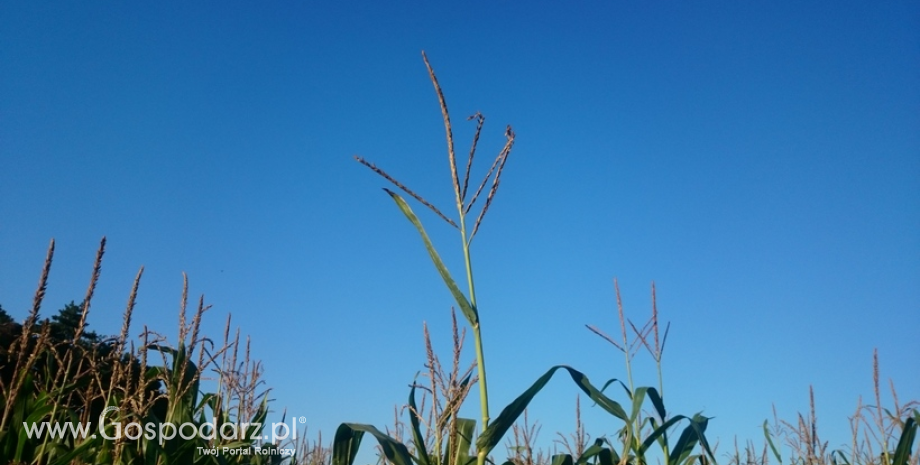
[0,2,920,460]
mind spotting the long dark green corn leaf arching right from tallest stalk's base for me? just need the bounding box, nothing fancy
[476,365,628,454]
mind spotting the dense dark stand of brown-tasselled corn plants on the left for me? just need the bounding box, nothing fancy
[0,238,288,465]
